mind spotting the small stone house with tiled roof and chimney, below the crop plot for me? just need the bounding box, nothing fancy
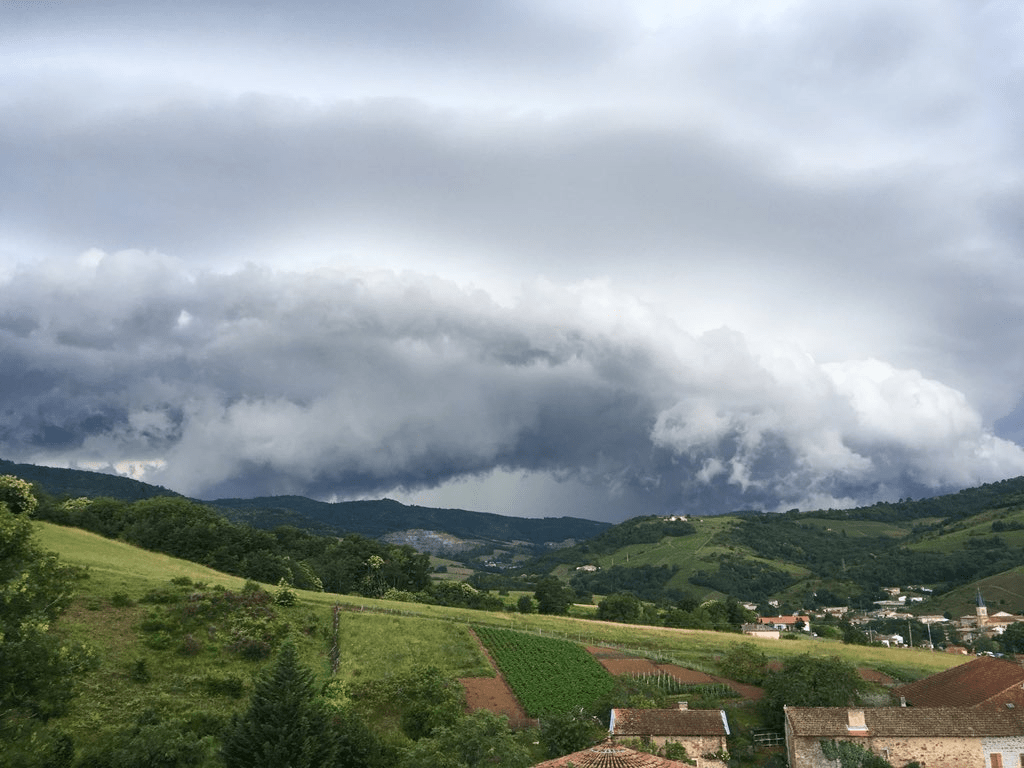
[608,701,729,765]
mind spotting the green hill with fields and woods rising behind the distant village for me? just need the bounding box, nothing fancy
[519,478,1024,614]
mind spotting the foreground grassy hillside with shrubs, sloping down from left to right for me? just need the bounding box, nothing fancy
[25,523,963,765]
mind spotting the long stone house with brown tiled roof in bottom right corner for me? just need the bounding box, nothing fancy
[785,707,1024,768]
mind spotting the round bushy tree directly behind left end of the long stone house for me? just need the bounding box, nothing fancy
[761,653,863,728]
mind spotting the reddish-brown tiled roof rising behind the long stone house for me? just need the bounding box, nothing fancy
[893,656,1024,712]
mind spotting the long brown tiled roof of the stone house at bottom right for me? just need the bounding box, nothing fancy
[785,707,1024,738]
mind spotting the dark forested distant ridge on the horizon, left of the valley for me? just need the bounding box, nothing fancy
[0,459,611,546]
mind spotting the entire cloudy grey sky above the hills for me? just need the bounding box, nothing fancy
[0,0,1024,521]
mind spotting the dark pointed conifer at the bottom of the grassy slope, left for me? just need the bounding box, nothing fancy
[221,641,341,768]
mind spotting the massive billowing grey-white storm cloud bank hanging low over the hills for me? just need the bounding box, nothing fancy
[0,252,1024,514]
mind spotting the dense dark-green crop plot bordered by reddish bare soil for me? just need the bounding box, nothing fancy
[474,627,614,717]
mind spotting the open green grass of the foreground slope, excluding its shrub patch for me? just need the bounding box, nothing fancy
[28,523,968,748]
